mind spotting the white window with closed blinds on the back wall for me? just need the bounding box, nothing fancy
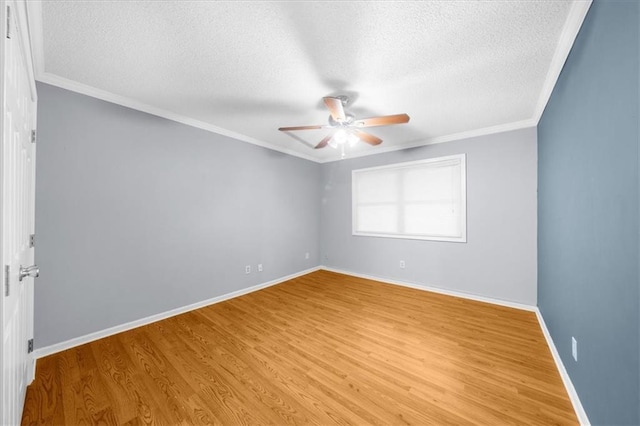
[352,154,467,242]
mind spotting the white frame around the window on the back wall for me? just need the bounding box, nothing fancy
[351,154,467,243]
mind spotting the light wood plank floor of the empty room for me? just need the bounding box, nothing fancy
[22,271,577,425]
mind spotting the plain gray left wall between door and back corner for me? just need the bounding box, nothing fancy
[35,84,320,347]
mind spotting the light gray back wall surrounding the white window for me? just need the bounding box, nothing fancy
[321,128,537,305]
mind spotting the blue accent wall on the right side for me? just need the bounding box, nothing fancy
[538,1,640,425]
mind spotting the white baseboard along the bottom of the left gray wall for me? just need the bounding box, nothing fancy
[33,266,320,364]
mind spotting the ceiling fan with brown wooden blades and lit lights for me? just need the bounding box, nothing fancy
[278,96,409,151]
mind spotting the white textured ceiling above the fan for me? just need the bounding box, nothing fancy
[30,0,588,161]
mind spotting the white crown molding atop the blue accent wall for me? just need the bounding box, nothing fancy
[532,0,592,126]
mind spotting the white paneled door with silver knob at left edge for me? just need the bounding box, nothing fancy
[0,0,37,425]
